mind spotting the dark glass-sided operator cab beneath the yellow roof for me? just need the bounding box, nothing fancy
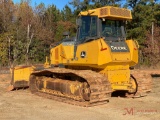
[77,16,126,44]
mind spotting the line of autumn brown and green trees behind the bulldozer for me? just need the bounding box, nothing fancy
[0,0,160,66]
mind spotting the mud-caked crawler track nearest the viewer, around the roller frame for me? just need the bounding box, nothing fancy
[29,68,112,107]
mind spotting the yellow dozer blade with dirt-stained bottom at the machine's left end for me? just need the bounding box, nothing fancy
[7,66,35,91]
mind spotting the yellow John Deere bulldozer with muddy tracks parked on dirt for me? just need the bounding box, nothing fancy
[10,6,151,106]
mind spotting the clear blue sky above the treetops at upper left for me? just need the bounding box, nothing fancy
[13,0,72,10]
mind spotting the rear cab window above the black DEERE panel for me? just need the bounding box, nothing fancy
[102,20,125,41]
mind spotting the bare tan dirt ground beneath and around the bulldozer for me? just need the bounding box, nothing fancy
[0,74,160,120]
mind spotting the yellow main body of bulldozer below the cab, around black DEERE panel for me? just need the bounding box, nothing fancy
[50,39,138,90]
